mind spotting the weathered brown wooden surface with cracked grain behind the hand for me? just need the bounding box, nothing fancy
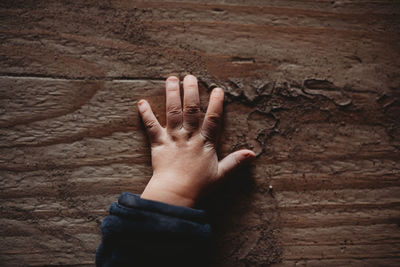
[0,0,400,266]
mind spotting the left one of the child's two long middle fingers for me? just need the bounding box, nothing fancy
[165,76,182,130]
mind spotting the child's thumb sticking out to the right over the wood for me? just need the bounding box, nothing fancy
[217,149,256,178]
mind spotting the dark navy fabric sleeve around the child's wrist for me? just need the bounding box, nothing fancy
[96,193,211,267]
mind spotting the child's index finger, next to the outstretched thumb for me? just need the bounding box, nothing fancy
[201,88,224,144]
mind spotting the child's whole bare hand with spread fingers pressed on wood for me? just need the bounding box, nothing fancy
[138,75,255,207]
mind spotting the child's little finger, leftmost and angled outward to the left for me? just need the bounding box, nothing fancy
[138,100,162,144]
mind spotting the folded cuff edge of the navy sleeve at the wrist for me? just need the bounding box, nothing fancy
[118,192,207,224]
